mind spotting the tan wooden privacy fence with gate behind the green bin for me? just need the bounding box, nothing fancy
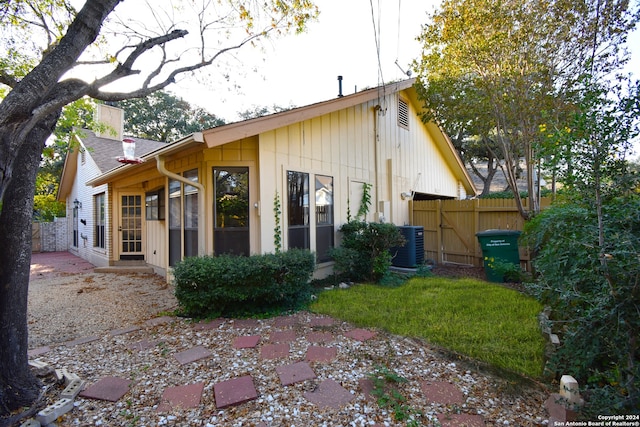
[410,198,551,271]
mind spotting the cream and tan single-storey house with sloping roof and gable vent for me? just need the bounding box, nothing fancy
[60,79,476,277]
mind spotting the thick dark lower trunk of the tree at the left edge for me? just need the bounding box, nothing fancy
[0,111,60,416]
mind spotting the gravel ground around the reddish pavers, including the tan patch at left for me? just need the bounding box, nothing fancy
[22,262,548,427]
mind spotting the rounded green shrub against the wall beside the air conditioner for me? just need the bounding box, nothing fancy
[331,221,405,282]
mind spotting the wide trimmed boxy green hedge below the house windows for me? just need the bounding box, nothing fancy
[173,249,315,318]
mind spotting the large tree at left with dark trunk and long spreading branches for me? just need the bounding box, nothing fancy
[0,0,317,416]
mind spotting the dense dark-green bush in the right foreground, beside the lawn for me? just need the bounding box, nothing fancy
[523,197,640,417]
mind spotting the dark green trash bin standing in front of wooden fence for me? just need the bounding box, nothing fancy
[476,230,520,283]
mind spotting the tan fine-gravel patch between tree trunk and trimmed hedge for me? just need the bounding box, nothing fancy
[28,267,177,348]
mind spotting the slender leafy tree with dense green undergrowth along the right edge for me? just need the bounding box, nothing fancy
[526,44,640,419]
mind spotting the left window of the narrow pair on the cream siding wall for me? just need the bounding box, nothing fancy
[287,171,310,249]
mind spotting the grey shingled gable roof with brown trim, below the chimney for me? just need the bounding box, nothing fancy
[58,129,168,201]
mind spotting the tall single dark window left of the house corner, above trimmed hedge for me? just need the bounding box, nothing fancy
[213,167,250,255]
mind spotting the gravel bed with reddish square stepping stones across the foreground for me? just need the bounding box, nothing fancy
[24,252,549,427]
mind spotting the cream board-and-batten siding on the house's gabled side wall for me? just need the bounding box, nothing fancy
[259,88,460,252]
